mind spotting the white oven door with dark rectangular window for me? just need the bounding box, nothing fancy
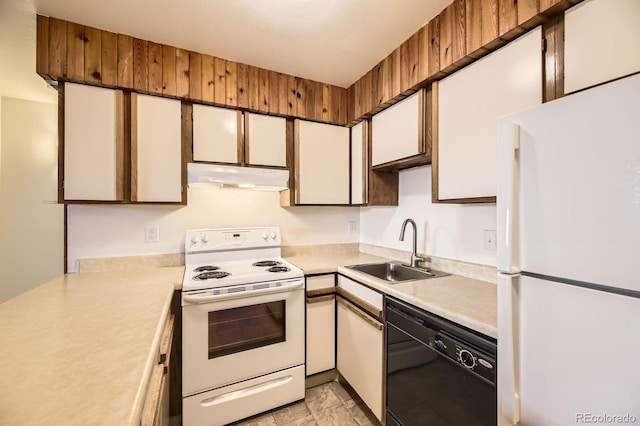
[182,279,304,397]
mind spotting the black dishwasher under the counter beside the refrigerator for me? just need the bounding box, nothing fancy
[385,298,497,426]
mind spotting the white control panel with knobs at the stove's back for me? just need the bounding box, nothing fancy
[185,226,281,253]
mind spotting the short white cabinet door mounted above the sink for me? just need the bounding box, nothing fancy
[371,90,426,167]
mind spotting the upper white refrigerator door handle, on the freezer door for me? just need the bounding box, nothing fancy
[498,123,520,273]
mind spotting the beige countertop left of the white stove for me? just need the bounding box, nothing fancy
[0,267,184,425]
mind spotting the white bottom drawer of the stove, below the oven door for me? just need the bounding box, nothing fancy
[183,365,304,426]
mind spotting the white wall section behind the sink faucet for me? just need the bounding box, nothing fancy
[360,166,496,266]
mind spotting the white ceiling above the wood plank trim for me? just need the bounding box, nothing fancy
[0,0,451,101]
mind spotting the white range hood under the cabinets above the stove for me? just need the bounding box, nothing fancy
[187,163,289,191]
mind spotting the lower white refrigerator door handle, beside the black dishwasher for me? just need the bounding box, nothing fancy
[498,273,520,426]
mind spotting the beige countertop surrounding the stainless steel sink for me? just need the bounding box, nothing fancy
[286,252,498,339]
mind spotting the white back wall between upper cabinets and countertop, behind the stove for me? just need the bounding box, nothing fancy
[68,188,359,272]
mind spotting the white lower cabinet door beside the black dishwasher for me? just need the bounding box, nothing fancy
[337,297,384,420]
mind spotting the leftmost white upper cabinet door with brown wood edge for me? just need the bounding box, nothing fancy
[63,83,124,201]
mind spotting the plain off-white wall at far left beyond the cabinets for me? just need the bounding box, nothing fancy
[0,97,64,302]
